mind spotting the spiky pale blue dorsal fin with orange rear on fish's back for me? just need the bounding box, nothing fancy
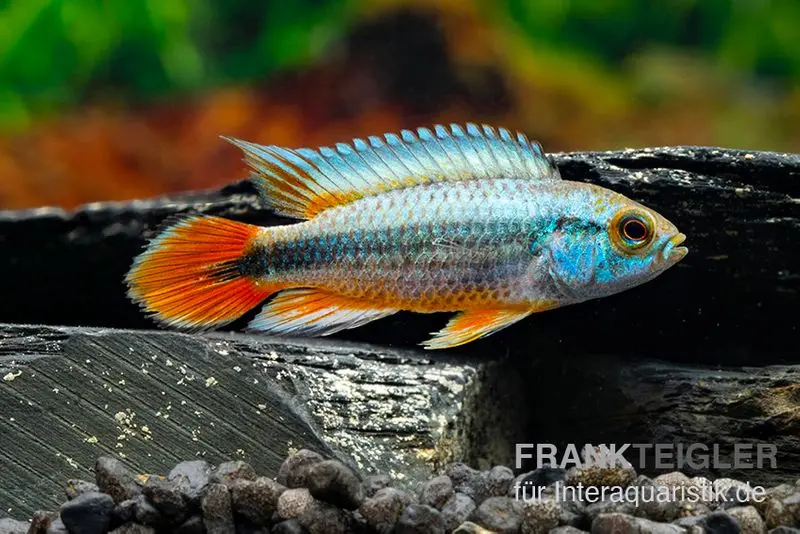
[223,123,560,219]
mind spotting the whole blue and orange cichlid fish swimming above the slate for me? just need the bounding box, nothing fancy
[125,123,688,350]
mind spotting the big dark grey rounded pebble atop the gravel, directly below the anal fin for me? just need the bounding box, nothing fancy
[306,460,364,510]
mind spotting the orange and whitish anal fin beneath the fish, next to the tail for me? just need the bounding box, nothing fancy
[247,288,398,336]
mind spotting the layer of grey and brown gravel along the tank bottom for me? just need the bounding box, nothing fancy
[9,456,800,534]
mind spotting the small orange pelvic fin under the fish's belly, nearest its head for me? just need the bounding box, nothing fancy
[422,308,537,350]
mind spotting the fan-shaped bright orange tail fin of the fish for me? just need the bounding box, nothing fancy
[126,216,281,330]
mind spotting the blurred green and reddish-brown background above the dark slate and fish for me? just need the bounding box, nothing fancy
[0,0,800,209]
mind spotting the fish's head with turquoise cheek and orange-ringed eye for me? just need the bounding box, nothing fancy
[547,186,688,302]
